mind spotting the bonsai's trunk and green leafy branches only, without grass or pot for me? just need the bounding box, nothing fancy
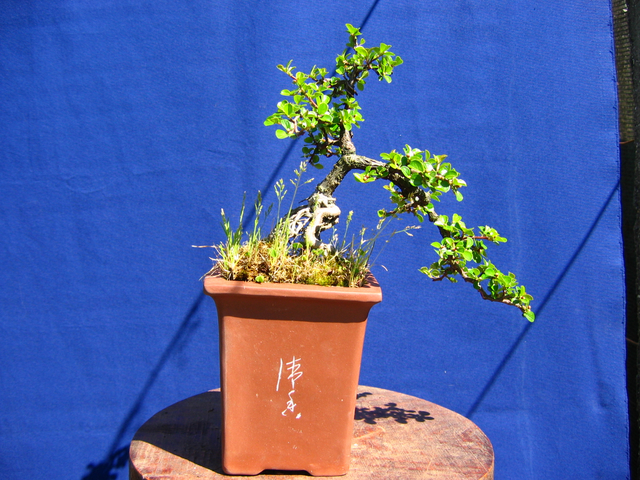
[265,25,535,321]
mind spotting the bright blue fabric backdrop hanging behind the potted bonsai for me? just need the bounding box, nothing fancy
[0,0,628,480]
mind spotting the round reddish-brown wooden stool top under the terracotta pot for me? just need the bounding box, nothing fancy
[129,386,494,480]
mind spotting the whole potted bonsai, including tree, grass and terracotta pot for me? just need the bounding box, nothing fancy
[205,25,535,475]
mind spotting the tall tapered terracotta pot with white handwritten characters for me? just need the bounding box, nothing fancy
[204,276,382,475]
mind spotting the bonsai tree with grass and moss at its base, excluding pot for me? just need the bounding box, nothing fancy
[206,25,535,321]
